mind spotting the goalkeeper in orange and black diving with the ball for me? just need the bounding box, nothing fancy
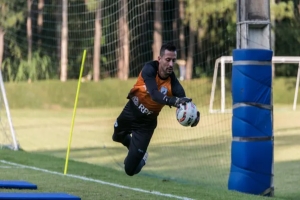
[112,43,200,176]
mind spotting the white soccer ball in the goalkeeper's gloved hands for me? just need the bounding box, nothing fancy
[176,102,198,126]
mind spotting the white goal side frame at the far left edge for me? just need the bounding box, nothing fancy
[0,68,19,151]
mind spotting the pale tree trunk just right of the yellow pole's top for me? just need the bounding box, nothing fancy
[93,1,102,82]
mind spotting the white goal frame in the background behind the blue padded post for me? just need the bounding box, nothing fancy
[209,56,300,113]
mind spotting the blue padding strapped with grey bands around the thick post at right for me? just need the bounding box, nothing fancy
[228,49,274,196]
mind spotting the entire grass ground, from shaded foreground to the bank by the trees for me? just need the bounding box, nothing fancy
[0,77,300,199]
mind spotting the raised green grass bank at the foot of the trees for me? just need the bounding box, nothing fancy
[5,78,299,109]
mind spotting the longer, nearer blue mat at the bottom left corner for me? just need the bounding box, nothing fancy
[0,192,81,200]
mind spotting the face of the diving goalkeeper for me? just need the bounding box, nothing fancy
[158,50,177,76]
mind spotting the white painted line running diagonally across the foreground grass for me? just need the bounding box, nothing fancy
[0,160,193,200]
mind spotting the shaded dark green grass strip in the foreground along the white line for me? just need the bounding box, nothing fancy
[0,150,277,200]
